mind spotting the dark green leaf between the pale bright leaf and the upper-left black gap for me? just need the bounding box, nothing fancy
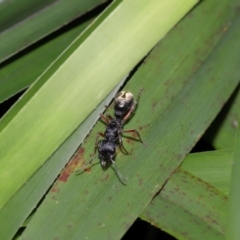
[0,16,93,102]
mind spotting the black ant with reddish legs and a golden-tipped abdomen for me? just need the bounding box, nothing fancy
[76,88,143,184]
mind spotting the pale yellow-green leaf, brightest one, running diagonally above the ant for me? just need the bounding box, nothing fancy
[0,0,196,221]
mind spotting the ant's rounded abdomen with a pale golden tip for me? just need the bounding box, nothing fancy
[114,91,134,119]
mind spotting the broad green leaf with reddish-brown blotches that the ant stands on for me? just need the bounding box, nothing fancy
[19,1,240,239]
